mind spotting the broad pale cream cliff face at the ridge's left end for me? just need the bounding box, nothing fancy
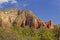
[0,9,17,28]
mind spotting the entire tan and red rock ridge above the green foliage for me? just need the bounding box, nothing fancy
[0,8,54,29]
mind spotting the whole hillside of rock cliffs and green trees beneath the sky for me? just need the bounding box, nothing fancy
[0,8,60,40]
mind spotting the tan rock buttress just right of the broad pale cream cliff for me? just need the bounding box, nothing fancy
[15,11,26,27]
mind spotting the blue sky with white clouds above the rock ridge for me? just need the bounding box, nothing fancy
[0,0,60,24]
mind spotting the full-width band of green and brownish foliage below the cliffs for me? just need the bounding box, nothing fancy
[0,25,60,40]
